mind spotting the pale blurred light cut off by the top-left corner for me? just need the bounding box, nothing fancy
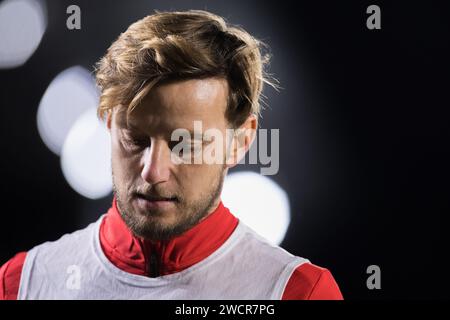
[0,0,47,69]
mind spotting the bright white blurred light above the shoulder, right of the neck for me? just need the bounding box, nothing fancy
[222,171,291,245]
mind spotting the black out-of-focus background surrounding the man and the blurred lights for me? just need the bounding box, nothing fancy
[0,0,450,299]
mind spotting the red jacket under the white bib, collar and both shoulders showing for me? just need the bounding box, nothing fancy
[0,199,343,300]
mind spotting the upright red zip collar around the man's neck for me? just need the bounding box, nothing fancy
[100,198,238,276]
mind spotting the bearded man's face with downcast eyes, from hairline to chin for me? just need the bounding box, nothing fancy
[108,78,228,240]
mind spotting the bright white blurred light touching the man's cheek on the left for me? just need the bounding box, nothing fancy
[61,109,112,199]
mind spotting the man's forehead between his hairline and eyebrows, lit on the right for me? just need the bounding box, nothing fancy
[118,78,228,132]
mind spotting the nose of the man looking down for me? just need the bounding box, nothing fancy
[141,139,170,184]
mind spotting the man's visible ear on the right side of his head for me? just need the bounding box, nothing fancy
[226,114,258,168]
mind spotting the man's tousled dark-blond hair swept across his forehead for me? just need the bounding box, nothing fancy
[95,10,277,127]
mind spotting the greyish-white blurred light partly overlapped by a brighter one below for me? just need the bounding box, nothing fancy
[37,66,99,155]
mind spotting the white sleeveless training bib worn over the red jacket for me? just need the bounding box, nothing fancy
[17,216,309,300]
